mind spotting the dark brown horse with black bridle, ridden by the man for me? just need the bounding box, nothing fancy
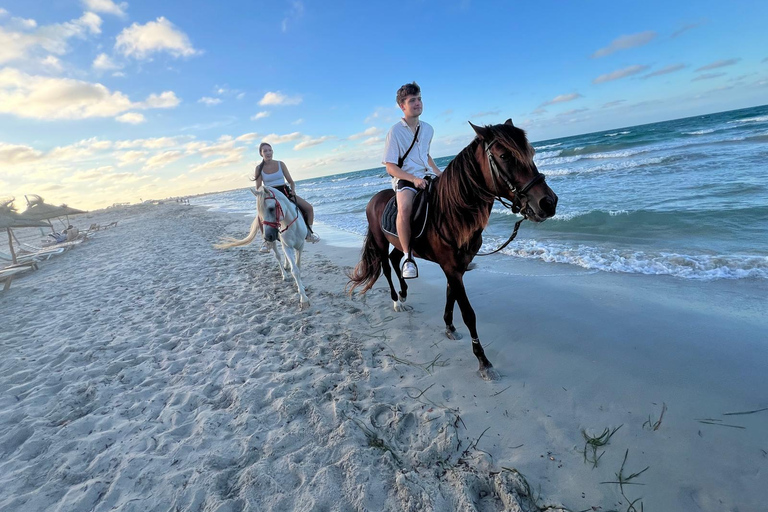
[349,119,557,380]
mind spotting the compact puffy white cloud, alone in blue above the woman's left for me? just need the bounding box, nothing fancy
[115,16,200,59]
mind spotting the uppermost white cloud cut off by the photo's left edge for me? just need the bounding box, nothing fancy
[0,12,101,64]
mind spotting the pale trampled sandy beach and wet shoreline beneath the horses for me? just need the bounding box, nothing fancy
[0,204,768,511]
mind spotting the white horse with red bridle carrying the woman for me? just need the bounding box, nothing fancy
[214,186,309,309]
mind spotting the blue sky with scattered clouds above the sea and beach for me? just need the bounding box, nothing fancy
[0,0,768,209]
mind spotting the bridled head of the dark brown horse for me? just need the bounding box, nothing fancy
[469,119,557,222]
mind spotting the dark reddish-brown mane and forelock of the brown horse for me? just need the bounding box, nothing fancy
[436,124,534,247]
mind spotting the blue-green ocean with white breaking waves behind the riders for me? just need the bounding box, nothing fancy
[192,105,768,280]
